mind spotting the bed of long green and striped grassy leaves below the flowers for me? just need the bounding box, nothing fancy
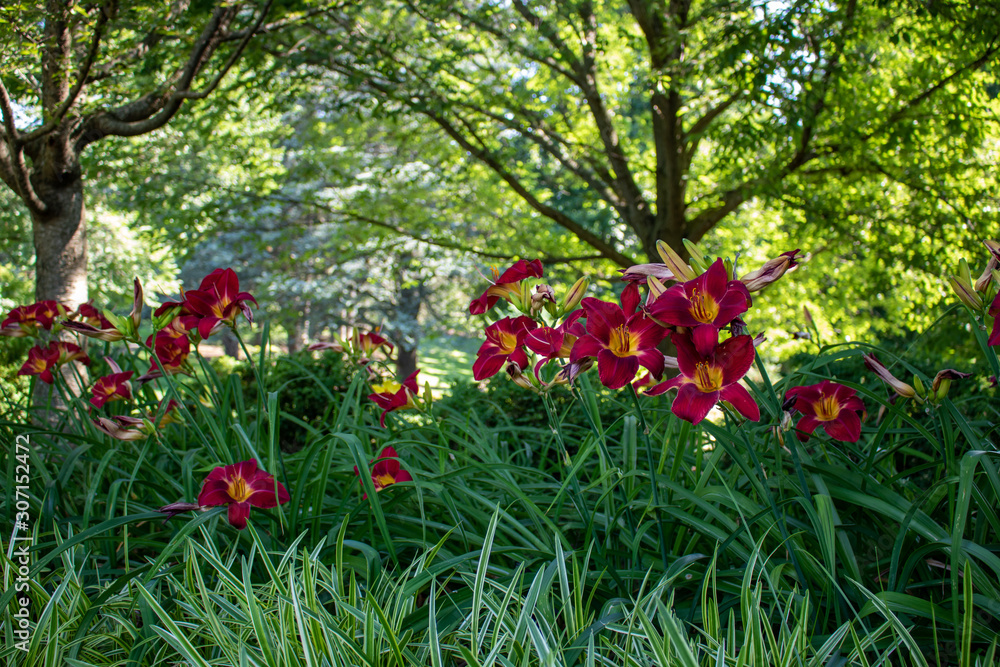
[0,314,1000,666]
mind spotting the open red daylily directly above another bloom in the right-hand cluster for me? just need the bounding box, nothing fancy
[647,259,750,329]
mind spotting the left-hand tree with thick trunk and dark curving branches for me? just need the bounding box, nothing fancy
[0,0,282,304]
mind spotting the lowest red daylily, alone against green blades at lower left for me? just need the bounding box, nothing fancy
[198,459,291,530]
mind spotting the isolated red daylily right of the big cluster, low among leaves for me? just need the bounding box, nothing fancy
[785,380,865,442]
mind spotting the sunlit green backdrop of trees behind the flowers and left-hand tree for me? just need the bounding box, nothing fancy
[0,0,1000,368]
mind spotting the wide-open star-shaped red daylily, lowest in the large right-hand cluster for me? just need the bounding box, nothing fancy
[646,324,760,424]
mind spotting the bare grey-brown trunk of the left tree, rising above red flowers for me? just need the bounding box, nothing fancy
[31,174,87,309]
